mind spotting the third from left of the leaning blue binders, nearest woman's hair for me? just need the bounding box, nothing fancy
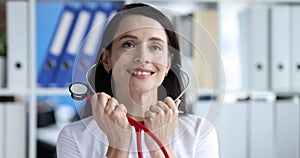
[72,6,112,82]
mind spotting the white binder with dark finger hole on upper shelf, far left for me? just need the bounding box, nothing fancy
[5,1,29,90]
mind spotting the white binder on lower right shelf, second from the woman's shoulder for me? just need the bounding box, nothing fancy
[248,101,275,158]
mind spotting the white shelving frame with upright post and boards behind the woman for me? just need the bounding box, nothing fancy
[0,0,299,158]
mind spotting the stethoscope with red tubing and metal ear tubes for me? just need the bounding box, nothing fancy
[69,63,190,158]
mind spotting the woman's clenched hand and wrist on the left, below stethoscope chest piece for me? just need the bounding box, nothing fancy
[91,92,132,151]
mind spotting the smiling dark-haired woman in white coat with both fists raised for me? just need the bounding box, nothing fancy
[57,4,218,158]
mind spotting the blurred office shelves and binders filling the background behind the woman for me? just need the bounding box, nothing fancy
[0,0,300,158]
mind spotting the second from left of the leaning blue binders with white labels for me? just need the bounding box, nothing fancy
[54,6,93,87]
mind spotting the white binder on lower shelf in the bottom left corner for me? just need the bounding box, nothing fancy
[0,102,26,158]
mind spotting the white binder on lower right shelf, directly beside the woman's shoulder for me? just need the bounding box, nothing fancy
[216,102,249,158]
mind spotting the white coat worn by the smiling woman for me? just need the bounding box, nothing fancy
[57,113,219,158]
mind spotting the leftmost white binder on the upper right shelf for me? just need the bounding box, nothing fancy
[239,5,270,91]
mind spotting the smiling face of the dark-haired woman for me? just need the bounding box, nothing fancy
[103,15,171,94]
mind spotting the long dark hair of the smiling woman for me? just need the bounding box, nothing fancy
[82,3,184,118]
